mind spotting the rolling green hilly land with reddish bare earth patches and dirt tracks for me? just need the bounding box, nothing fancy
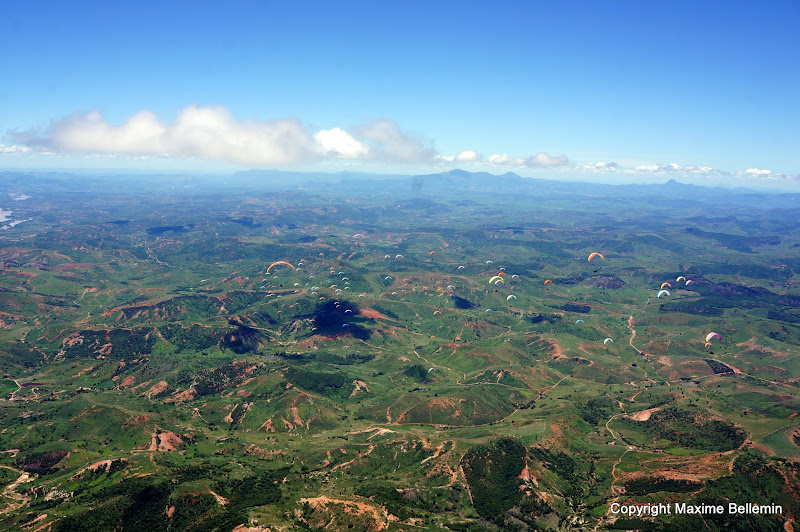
[0,172,800,531]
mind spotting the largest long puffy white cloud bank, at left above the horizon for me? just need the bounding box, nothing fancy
[10,105,444,166]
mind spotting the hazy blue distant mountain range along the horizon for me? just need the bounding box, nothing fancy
[0,169,800,209]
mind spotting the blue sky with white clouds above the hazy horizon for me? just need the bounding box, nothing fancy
[0,0,800,191]
